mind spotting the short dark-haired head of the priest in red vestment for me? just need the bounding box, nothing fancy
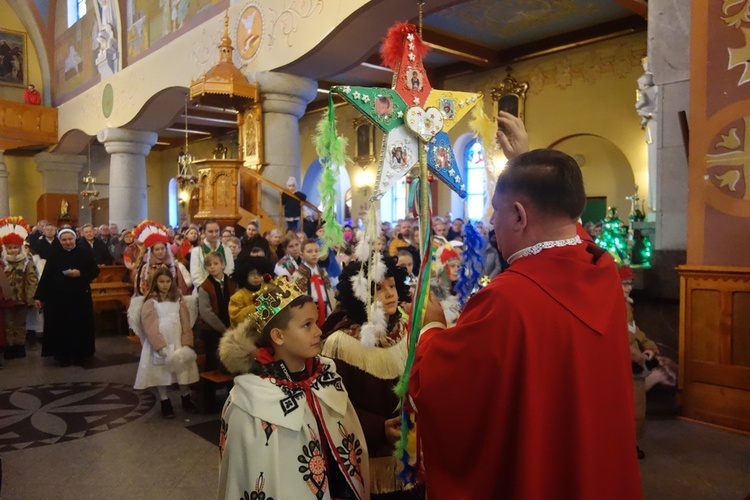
[492,149,586,258]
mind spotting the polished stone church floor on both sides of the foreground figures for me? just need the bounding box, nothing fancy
[0,337,750,500]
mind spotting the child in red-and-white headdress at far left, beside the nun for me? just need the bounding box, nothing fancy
[0,217,39,359]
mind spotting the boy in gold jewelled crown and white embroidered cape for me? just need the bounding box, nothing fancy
[218,277,369,499]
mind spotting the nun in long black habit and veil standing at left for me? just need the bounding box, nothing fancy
[34,228,99,366]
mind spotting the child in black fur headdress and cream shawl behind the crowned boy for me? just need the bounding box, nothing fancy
[321,257,424,499]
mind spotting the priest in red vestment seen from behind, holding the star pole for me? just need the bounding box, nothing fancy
[410,150,642,500]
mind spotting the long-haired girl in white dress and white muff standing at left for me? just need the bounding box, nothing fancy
[128,267,198,418]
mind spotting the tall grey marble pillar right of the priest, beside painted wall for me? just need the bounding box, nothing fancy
[648,0,690,250]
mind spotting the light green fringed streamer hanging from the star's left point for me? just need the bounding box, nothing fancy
[315,94,347,252]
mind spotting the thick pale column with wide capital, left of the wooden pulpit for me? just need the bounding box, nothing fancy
[96,128,157,228]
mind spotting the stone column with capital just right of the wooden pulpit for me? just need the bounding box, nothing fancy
[256,73,318,225]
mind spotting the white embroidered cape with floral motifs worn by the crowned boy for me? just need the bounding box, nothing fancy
[218,348,370,500]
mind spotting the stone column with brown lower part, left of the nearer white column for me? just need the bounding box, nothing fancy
[34,152,86,225]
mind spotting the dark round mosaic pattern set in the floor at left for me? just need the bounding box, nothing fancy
[0,382,156,452]
